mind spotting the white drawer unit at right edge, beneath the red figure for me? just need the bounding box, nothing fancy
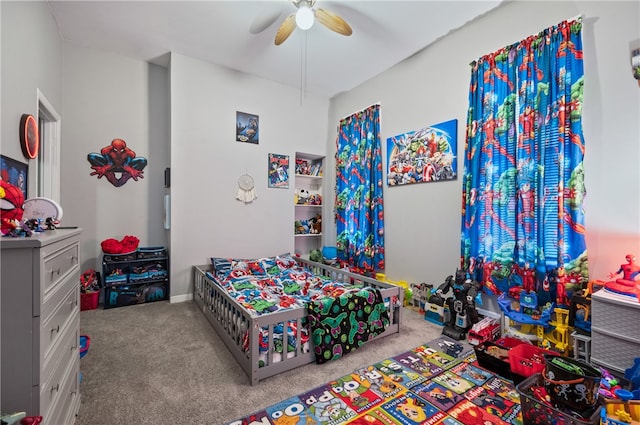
[591,289,640,373]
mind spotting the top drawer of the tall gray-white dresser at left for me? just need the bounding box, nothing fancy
[42,240,80,303]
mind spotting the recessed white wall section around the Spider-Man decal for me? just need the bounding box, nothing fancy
[61,43,169,270]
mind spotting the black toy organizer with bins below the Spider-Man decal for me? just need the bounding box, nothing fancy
[102,247,169,308]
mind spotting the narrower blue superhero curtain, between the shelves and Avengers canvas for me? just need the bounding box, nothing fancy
[335,105,384,273]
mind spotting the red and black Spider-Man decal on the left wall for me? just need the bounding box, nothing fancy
[87,139,147,187]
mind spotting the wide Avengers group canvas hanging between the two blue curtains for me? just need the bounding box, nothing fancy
[387,120,458,186]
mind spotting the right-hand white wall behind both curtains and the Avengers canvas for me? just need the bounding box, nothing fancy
[324,1,640,285]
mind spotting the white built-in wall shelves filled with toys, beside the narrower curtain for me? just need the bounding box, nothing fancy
[293,152,325,258]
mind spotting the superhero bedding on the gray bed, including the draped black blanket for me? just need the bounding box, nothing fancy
[207,261,389,362]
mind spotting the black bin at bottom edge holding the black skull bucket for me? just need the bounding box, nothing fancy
[516,373,602,425]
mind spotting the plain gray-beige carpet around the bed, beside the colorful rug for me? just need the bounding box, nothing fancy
[76,301,442,425]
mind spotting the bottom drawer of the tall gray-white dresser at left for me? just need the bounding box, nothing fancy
[42,352,80,425]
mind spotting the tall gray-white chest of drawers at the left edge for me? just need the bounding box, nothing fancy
[0,229,80,425]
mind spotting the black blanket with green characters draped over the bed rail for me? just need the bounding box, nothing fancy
[308,288,389,363]
